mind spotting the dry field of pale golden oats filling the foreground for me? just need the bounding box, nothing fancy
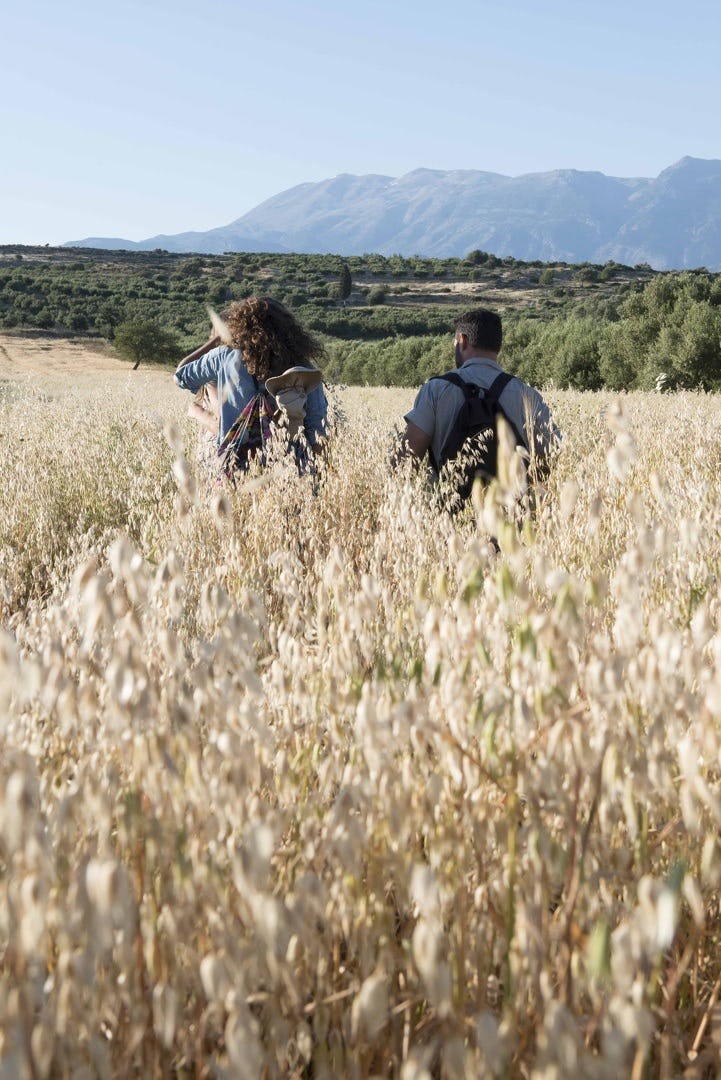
[0,339,721,1080]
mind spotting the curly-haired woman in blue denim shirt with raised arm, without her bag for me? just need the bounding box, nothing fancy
[175,296,328,460]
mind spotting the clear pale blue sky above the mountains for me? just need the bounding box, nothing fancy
[0,0,721,244]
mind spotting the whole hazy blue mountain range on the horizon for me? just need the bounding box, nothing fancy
[66,158,721,270]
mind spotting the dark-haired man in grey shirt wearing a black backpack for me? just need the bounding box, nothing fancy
[405,308,560,498]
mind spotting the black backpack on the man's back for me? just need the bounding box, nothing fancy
[430,372,525,499]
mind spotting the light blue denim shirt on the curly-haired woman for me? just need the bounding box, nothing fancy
[175,345,328,446]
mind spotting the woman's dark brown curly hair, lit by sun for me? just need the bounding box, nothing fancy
[223,296,325,381]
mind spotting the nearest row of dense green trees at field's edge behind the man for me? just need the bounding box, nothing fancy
[329,272,721,390]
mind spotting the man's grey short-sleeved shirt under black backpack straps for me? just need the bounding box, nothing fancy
[405,356,560,461]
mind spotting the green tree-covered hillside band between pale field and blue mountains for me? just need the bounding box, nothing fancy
[0,248,721,390]
